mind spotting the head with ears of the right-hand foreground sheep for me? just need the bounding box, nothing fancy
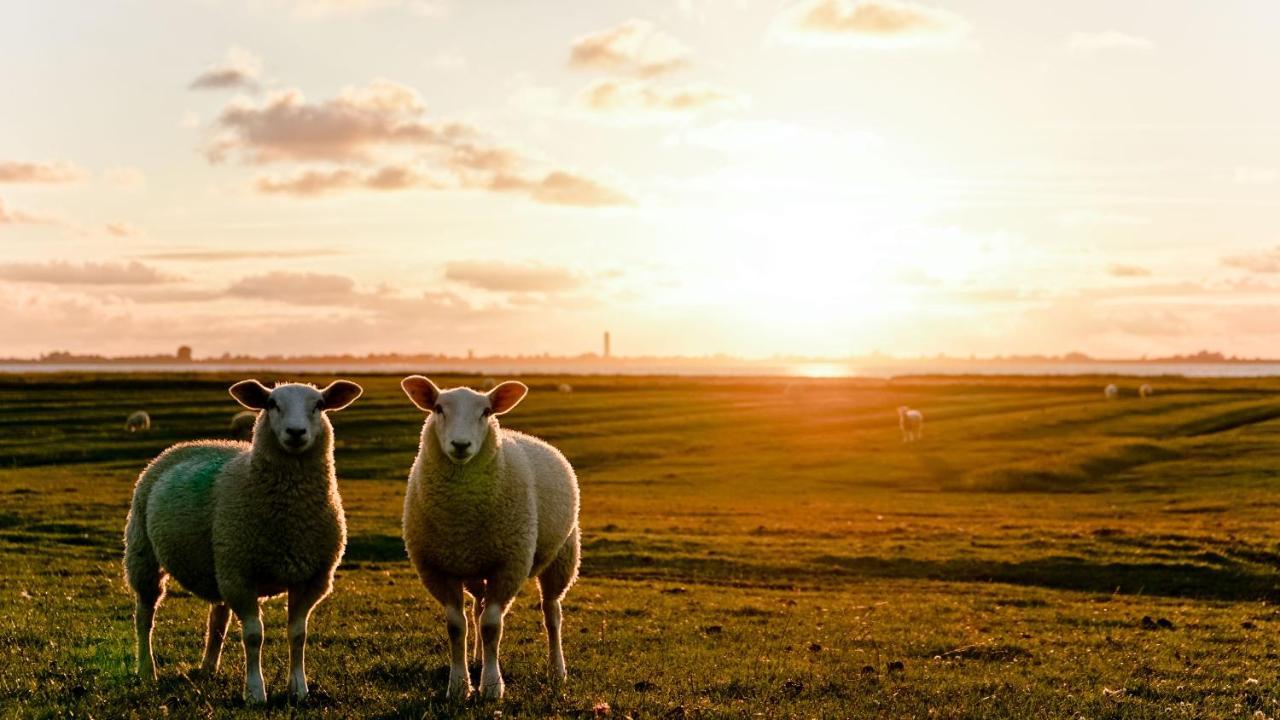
[401,375,529,465]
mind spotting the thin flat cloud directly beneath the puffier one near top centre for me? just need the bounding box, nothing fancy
[577,78,742,118]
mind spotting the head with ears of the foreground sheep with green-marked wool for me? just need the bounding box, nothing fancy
[230,380,364,455]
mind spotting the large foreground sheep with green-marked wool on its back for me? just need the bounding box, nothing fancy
[124,380,364,702]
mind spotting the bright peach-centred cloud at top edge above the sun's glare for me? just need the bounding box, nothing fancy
[778,0,969,47]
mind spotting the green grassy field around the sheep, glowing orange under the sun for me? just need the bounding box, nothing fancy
[0,375,1280,719]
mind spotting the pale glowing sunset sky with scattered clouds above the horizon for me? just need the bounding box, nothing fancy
[0,0,1280,357]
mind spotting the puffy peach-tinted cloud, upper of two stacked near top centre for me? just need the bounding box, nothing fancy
[568,19,690,77]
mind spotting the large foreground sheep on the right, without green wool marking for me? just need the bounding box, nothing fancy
[401,375,581,700]
